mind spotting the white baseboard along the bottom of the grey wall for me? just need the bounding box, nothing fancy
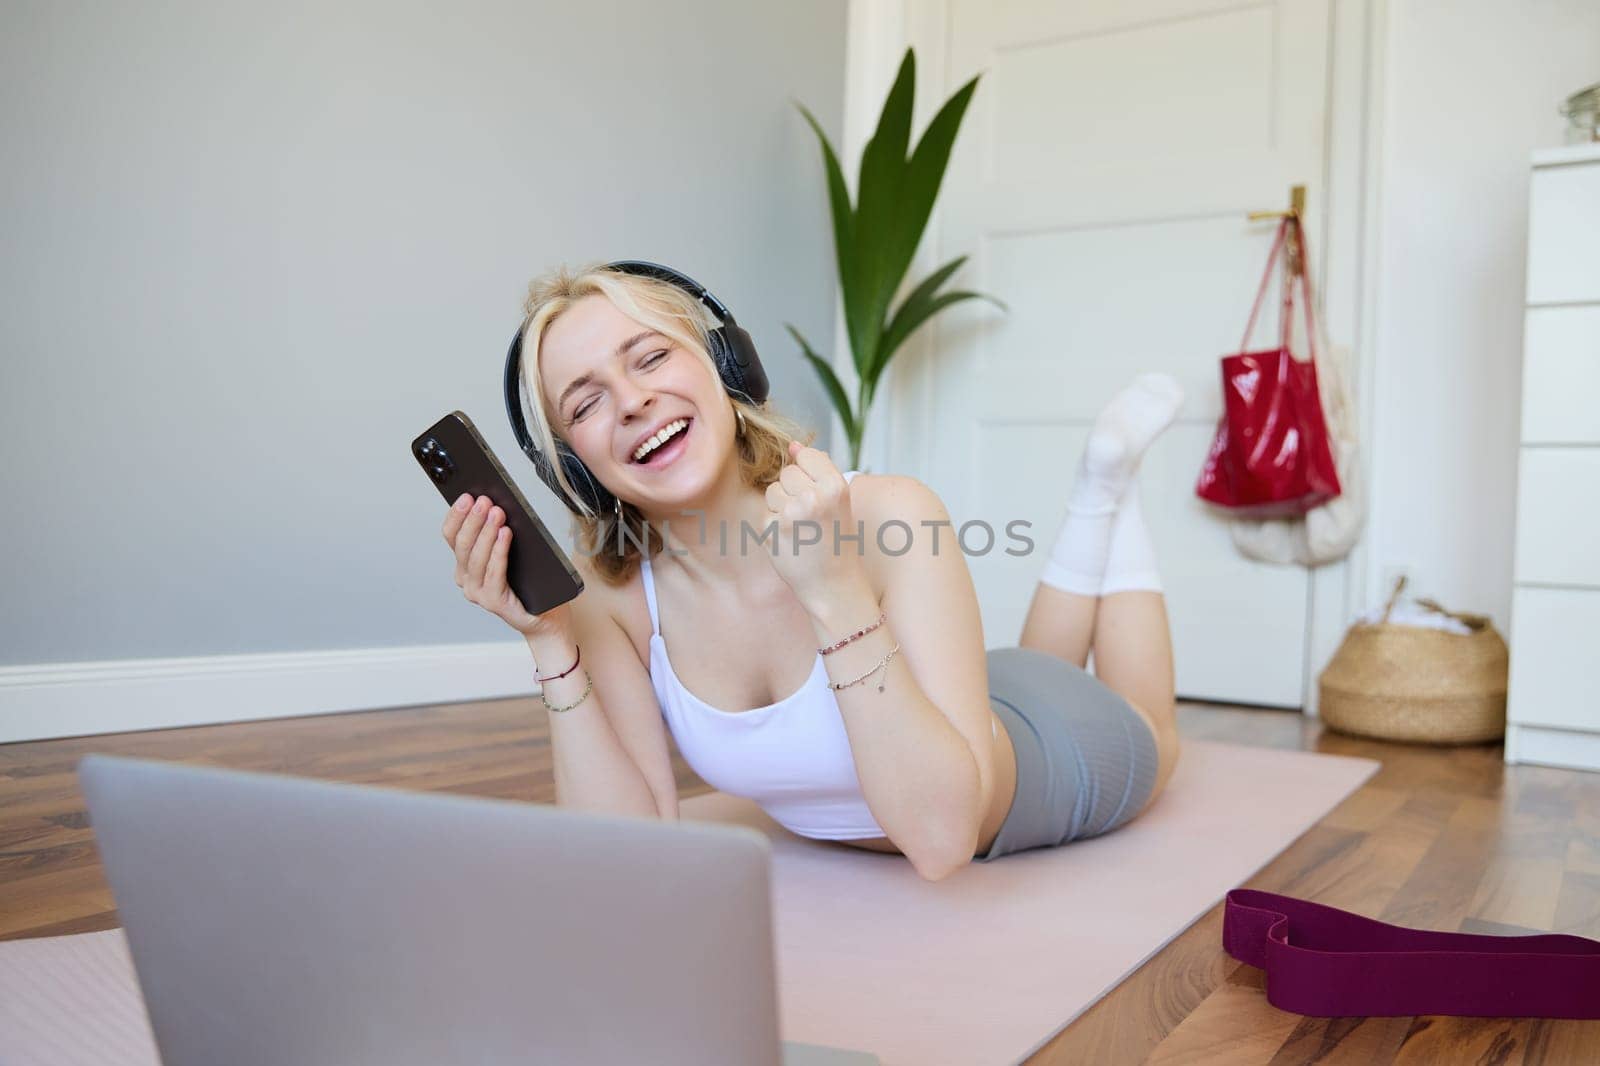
[0,640,539,744]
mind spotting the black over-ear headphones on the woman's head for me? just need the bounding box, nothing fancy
[506,259,768,515]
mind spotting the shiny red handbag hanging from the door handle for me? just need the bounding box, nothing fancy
[1195,214,1341,517]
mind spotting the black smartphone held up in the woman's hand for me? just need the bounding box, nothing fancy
[411,411,584,615]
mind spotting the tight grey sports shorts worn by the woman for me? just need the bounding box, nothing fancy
[974,647,1157,863]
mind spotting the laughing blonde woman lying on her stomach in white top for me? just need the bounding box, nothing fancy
[443,259,1182,880]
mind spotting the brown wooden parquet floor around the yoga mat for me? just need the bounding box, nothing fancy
[0,699,1600,1066]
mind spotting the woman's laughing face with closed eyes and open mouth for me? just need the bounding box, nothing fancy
[539,295,736,514]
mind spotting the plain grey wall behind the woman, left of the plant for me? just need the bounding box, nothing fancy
[0,0,845,664]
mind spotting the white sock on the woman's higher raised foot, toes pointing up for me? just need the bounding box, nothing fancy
[1038,373,1184,595]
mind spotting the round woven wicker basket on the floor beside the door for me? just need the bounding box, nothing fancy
[1317,578,1509,744]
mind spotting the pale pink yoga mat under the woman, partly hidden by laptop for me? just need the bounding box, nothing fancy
[0,741,1378,1066]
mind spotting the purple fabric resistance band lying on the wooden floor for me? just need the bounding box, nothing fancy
[1222,888,1600,1018]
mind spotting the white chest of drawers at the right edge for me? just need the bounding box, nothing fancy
[1506,144,1600,770]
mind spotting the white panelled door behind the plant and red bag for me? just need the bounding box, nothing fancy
[894,0,1330,706]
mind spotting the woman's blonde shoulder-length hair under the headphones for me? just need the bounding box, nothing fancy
[522,264,816,584]
